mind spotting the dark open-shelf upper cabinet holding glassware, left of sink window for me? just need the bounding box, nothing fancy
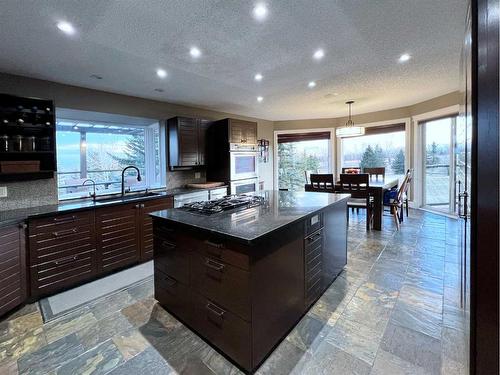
[0,94,57,182]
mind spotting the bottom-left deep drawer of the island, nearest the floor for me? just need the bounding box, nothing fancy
[154,268,191,323]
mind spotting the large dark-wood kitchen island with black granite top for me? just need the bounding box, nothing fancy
[152,191,349,372]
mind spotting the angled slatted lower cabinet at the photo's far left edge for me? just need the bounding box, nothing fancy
[0,225,26,316]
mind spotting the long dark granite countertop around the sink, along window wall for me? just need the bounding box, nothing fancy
[0,186,227,227]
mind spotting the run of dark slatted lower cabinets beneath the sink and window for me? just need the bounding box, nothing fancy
[27,197,173,300]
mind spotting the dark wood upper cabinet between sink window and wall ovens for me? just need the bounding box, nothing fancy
[167,117,210,170]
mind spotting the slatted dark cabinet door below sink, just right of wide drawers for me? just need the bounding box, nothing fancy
[95,203,141,273]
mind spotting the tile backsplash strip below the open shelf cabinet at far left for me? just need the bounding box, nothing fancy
[0,178,57,211]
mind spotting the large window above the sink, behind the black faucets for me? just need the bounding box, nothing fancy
[56,109,166,200]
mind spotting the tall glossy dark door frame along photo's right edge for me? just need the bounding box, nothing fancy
[470,0,500,375]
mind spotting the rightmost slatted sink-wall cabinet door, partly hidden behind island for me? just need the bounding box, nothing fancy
[139,197,174,262]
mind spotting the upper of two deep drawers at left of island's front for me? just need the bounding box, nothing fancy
[154,236,191,284]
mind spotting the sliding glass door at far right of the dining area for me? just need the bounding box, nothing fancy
[421,116,463,214]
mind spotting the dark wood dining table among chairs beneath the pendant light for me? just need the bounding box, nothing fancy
[305,176,399,230]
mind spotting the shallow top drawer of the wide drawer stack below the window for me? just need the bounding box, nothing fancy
[28,210,94,236]
